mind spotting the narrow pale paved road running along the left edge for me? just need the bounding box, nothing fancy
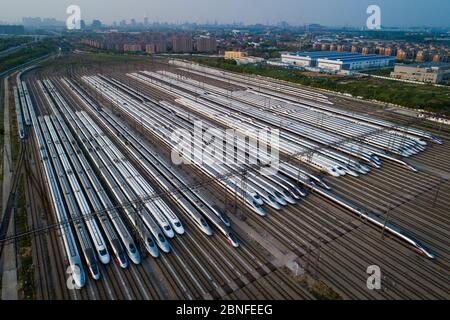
[0,77,17,300]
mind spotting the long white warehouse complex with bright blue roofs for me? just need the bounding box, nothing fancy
[281,51,396,72]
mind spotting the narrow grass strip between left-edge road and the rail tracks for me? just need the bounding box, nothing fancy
[15,175,35,300]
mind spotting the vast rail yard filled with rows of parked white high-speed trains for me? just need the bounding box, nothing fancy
[2,57,450,300]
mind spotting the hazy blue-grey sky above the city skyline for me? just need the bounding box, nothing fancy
[0,0,450,27]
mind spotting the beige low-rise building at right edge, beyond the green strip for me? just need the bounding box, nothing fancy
[391,62,450,83]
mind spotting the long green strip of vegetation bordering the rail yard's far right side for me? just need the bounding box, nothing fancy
[185,57,450,115]
